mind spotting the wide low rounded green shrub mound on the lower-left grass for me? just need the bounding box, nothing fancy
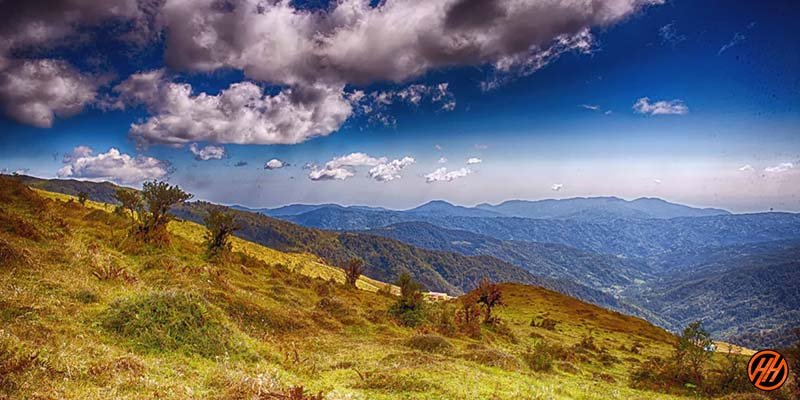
[100,291,249,357]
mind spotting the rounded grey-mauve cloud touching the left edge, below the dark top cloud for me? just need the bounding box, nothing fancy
[0,59,97,128]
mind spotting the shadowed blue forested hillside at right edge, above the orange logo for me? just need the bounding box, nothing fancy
[631,240,800,348]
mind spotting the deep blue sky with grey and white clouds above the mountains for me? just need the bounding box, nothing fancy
[0,0,800,212]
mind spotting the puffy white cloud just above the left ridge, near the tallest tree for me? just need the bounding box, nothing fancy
[58,146,169,183]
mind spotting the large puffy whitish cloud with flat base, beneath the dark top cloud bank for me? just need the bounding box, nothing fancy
[114,71,352,145]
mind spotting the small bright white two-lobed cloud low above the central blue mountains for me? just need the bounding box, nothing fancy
[308,152,415,182]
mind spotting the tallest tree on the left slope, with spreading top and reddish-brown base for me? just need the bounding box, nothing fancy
[141,181,192,242]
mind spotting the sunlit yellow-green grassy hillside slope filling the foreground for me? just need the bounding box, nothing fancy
[0,181,740,399]
